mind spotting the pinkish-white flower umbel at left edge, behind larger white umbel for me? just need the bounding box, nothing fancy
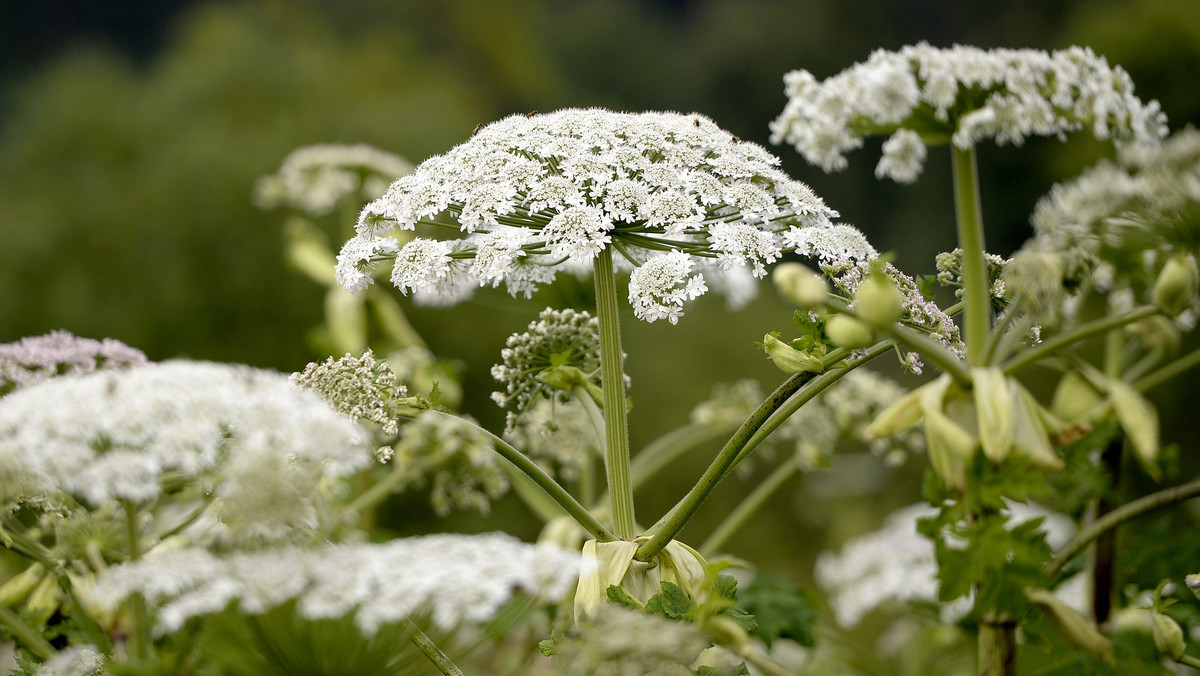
[0,331,146,395]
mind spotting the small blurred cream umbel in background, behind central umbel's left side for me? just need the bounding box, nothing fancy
[254,144,413,216]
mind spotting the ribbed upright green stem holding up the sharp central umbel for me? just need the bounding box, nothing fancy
[593,247,637,540]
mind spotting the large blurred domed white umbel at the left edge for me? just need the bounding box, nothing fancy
[0,361,373,537]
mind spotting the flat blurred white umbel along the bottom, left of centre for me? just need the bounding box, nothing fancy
[88,533,580,636]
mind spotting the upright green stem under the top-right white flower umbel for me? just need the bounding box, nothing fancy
[950,144,991,366]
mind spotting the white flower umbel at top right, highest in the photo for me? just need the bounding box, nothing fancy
[770,42,1166,183]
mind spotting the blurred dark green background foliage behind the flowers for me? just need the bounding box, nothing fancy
[0,0,1200,609]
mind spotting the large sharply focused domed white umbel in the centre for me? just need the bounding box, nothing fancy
[337,109,836,321]
